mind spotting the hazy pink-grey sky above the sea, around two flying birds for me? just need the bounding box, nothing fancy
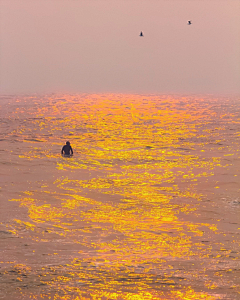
[0,0,240,94]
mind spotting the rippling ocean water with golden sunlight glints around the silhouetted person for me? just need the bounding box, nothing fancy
[0,94,240,300]
